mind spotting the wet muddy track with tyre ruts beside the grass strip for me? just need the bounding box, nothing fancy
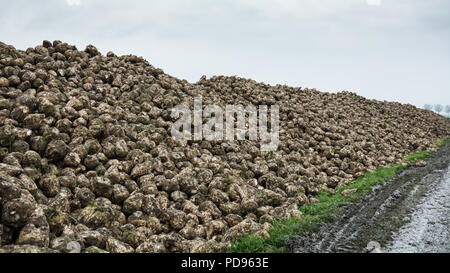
[286,144,450,253]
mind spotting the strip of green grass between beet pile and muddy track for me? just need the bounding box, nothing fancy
[227,138,450,253]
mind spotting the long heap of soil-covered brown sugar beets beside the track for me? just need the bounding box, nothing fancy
[0,41,450,253]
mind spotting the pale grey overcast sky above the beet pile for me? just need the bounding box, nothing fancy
[0,0,450,107]
